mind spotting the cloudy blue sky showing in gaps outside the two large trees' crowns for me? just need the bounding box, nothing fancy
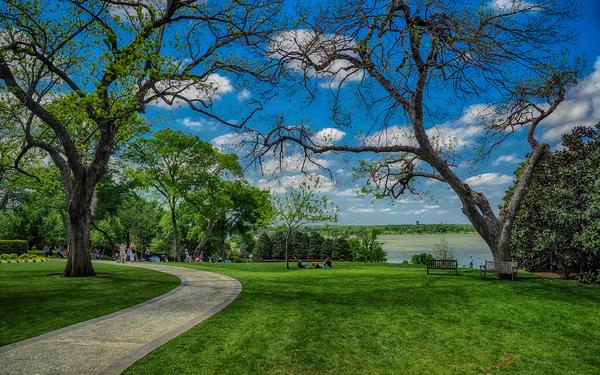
[152,0,600,224]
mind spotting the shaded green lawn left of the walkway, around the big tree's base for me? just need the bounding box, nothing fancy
[0,260,181,346]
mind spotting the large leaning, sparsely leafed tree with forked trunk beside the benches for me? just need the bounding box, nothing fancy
[254,0,582,261]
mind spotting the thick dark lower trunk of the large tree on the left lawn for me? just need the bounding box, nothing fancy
[62,194,96,277]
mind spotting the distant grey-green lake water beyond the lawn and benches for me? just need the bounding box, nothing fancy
[377,234,492,268]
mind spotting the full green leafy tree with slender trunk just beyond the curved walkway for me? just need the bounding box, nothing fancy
[123,128,241,262]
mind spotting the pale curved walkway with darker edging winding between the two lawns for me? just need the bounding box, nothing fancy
[0,263,242,375]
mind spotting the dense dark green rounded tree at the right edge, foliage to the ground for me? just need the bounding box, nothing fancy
[504,124,600,276]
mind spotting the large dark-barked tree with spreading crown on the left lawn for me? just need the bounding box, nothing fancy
[0,0,280,276]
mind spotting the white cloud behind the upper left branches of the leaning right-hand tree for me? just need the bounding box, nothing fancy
[269,30,364,88]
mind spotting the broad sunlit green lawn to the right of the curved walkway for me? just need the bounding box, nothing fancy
[125,263,600,375]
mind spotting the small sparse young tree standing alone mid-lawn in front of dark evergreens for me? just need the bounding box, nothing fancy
[272,188,337,269]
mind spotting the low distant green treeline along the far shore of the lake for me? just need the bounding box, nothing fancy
[300,224,477,236]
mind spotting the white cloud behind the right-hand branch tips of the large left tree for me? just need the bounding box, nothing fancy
[149,74,233,108]
